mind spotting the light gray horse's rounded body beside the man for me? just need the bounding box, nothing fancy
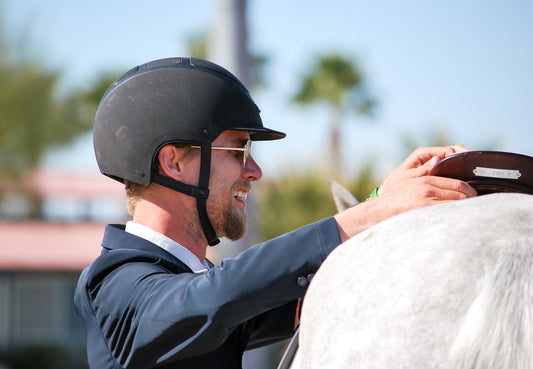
[292,193,533,369]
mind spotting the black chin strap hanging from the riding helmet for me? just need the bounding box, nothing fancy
[152,143,220,246]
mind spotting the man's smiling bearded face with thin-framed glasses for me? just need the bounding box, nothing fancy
[207,131,262,240]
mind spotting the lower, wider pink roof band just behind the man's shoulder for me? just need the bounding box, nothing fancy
[0,222,105,271]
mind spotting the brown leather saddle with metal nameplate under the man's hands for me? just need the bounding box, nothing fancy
[429,151,533,195]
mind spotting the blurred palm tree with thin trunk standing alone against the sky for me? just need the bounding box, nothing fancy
[293,54,376,179]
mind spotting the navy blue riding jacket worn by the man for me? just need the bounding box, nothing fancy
[75,218,340,369]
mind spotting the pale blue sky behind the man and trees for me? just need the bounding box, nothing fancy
[0,0,533,180]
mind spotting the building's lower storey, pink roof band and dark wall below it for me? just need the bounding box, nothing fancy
[0,222,103,348]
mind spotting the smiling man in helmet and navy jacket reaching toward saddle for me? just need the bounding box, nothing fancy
[75,58,476,369]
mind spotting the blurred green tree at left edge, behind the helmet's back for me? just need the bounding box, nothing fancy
[0,29,116,217]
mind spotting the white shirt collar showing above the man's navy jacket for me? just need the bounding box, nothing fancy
[126,221,209,273]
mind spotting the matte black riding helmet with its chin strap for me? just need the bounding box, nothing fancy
[93,58,285,246]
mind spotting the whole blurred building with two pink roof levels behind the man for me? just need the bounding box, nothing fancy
[0,171,127,366]
